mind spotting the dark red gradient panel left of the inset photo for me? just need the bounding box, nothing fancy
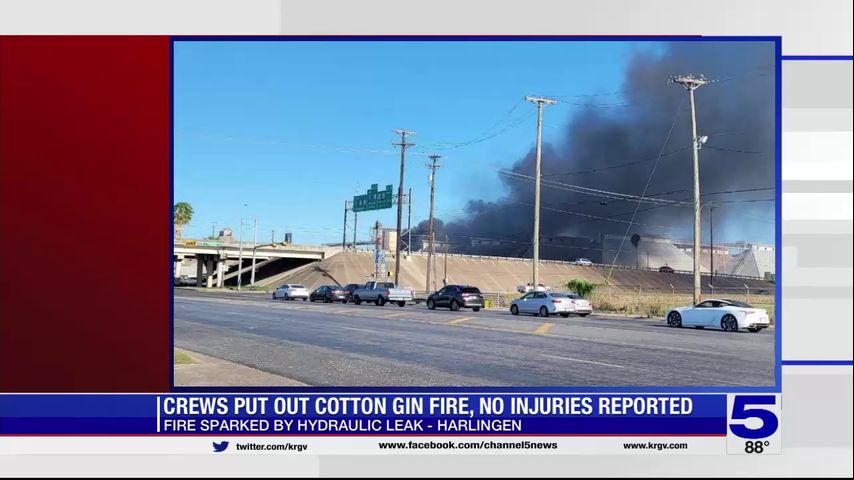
[0,36,171,392]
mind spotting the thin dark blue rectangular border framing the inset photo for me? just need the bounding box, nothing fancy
[168,35,784,394]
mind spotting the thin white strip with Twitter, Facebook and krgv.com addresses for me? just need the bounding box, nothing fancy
[0,435,727,455]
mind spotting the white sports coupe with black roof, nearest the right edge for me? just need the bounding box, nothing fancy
[665,299,771,333]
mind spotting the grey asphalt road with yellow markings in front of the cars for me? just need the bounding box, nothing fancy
[174,289,774,386]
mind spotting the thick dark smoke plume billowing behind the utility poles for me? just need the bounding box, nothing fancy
[413,42,775,260]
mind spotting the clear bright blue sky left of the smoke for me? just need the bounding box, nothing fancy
[174,41,658,243]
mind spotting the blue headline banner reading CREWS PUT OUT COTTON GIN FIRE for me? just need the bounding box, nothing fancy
[0,394,727,435]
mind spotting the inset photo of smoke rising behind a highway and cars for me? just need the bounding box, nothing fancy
[171,40,779,387]
